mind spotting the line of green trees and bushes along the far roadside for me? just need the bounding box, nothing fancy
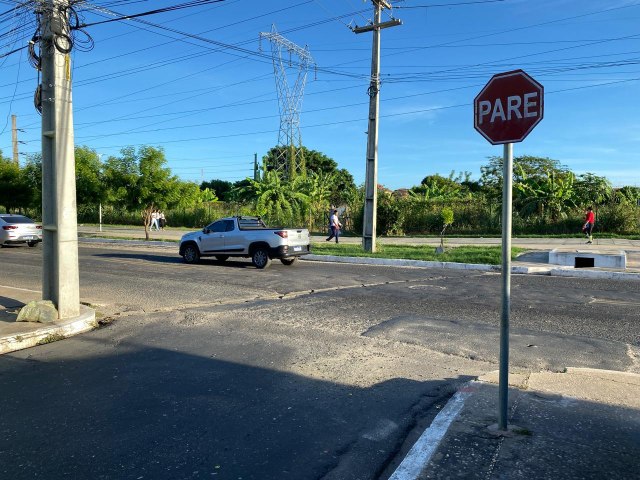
[0,146,640,235]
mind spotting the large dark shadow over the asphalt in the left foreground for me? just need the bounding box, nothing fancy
[0,329,468,480]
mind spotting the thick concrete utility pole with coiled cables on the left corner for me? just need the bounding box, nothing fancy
[40,0,80,319]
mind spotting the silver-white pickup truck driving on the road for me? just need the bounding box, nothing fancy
[180,217,311,268]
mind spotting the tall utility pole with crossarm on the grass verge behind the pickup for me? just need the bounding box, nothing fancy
[353,0,402,253]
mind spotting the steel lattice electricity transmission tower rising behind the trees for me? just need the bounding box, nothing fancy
[260,25,314,178]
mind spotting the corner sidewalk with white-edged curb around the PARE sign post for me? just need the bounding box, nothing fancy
[389,368,640,480]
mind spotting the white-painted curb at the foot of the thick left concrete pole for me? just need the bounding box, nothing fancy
[0,305,98,355]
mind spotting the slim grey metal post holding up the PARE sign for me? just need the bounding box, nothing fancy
[498,143,513,430]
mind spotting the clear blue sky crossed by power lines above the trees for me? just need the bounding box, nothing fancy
[0,0,640,189]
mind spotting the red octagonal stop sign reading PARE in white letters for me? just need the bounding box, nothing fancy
[473,70,544,145]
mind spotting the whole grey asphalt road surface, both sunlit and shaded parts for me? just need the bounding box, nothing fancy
[0,246,640,480]
